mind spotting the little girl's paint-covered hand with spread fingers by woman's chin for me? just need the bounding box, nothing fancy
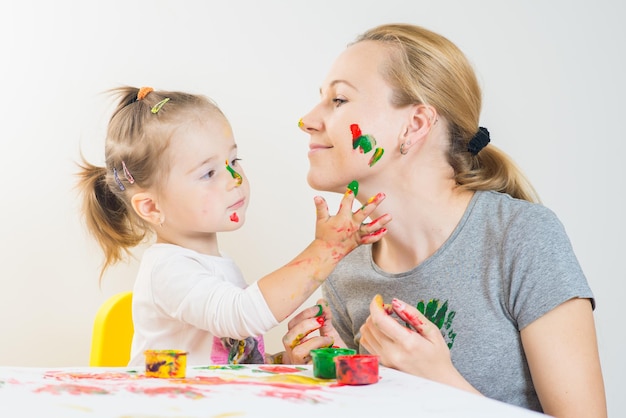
[315,189,391,260]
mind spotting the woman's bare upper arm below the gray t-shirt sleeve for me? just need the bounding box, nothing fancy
[521,298,607,418]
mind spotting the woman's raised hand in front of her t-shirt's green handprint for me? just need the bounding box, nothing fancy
[361,295,477,392]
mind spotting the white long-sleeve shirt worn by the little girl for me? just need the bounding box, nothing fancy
[129,244,278,366]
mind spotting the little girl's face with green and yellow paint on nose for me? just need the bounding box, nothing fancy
[157,115,250,248]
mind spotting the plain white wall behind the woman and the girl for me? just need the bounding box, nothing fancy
[0,0,626,416]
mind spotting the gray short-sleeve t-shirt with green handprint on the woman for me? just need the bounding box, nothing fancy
[322,192,595,411]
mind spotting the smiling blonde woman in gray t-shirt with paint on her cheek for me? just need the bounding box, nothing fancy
[286,24,606,417]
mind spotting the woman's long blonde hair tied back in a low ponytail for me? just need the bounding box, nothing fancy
[355,24,540,202]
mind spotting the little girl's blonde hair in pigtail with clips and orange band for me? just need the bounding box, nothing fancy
[77,87,225,278]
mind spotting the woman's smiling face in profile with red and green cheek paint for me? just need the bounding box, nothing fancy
[300,41,409,193]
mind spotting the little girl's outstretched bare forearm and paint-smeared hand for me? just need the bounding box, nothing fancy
[258,190,391,322]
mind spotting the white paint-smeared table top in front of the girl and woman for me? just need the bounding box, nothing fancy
[0,365,543,418]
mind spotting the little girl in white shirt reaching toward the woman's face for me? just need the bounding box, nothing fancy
[79,87,390,366]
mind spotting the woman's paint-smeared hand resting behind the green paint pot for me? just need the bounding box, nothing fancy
[283,299,345,364]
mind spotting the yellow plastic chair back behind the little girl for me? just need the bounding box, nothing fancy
[89,291,135,367]
